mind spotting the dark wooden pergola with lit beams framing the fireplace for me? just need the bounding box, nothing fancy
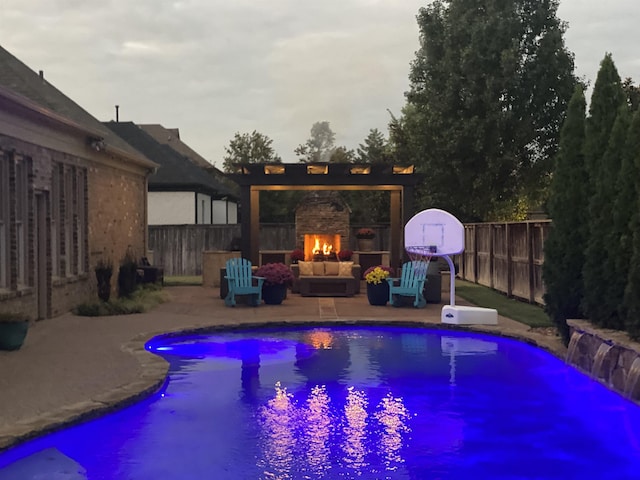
[227,162,423,267]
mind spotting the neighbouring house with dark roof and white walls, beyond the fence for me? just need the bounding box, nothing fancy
[104,122,238,225]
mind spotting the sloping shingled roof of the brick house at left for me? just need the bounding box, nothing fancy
[0,47,155,168]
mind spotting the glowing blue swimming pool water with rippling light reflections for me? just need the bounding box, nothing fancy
[0,326,640,480]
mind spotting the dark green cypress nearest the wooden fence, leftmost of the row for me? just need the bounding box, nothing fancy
[542,85,588,342]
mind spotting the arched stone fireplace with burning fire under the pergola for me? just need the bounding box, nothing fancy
[296,191,350,261]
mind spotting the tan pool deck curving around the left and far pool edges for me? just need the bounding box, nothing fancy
[0,286,566,451]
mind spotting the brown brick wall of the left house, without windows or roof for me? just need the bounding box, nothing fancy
[0,135,146,318]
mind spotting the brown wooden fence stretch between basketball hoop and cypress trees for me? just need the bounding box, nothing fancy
[459,220,551,305]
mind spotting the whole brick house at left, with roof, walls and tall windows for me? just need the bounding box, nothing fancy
[0,47,157,319]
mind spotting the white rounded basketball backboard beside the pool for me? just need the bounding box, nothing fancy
[404,208,464,256]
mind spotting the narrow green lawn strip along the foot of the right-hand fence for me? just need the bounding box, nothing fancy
[456,279,553,327]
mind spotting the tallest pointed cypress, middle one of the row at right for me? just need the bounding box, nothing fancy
[583,54,626,327]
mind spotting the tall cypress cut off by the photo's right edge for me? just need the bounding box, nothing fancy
[620,110,640,339]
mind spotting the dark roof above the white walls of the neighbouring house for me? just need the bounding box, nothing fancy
[104,121,235,198]
